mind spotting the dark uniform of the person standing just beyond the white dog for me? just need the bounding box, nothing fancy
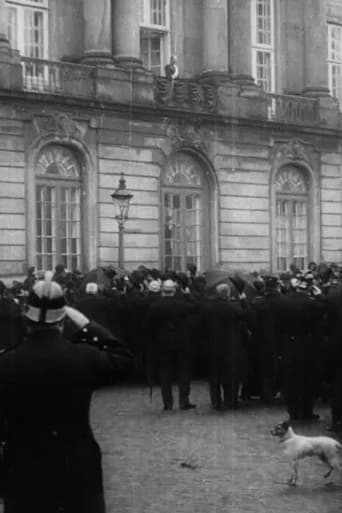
[275,291,323,420]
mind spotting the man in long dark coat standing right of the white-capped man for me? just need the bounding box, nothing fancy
[202,284,248,410]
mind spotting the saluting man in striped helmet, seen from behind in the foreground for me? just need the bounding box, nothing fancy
[0,274,131,513]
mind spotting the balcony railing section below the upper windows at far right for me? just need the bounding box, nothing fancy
[267,94,320,125]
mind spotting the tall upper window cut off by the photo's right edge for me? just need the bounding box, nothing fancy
[328,24,342,104]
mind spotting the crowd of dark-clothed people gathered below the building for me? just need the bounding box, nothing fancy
[1,262,342,429]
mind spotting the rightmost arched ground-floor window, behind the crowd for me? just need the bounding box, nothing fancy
[275,166,308,271]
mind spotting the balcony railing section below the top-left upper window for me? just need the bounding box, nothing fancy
[21,57,96,98]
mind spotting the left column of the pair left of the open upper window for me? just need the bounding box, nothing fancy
[82,0,113,65]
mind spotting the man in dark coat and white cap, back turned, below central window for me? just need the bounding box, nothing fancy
[146,280,196,410]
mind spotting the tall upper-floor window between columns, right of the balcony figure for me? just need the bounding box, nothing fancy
[251,0,275,92]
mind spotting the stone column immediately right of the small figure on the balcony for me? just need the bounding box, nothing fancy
[202,0,228,78]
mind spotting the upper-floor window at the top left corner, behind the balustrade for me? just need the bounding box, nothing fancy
[6,0,48,59]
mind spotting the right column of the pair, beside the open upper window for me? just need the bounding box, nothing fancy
[113,0,142,68]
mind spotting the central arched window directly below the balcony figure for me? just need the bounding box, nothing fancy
[162,152,210,271]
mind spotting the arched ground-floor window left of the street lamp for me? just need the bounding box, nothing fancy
[36,145,82,271]
